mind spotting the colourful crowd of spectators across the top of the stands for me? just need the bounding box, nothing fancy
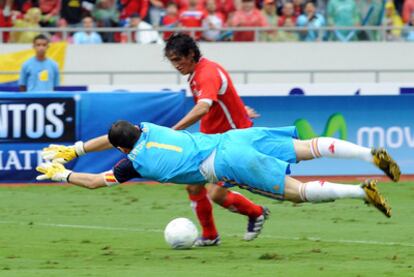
[0,0,414,44]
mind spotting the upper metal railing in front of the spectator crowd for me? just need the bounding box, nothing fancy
[0,26,414,43]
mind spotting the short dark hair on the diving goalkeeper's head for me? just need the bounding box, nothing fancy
[108,120,141,149]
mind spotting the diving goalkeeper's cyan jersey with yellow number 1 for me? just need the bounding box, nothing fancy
[128,122,221,184]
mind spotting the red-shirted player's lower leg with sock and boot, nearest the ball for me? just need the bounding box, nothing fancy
[186,185,220,246]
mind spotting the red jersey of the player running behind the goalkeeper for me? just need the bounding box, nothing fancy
[188,58,253,134]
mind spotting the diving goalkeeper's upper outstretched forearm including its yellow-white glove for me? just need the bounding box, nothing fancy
[41,135,113,164]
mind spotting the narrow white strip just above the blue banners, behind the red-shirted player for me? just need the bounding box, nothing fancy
[88,83,414,96]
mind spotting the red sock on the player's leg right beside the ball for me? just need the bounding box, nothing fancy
[188,188,218,239]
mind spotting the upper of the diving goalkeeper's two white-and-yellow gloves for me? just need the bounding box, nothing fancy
[41,141,86,164]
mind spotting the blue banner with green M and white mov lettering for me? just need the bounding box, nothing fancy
[243,95,414,175]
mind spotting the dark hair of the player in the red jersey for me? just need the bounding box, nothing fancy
[164,33,201,62]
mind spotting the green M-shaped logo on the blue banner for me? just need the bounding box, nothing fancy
[294,113,348,140]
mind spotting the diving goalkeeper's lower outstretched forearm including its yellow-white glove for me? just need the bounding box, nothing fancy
[36,162,107,189]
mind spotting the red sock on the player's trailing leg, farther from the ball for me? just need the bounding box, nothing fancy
[221,191,263,217]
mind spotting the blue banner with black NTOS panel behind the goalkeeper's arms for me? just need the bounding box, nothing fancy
[0,92,185,183]
